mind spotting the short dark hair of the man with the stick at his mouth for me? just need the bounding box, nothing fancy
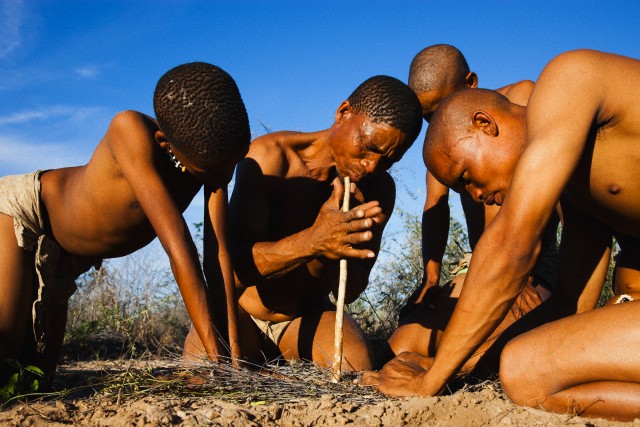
[347,76,422,141]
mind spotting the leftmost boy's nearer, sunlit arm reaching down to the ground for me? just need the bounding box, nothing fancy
[108,112,225,359]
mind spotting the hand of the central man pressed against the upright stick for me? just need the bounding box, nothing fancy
[310,178,383,259]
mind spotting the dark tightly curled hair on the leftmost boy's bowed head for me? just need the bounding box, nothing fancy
[153,62,251,167]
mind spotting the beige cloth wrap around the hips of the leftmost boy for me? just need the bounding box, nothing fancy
[0,171,101,353]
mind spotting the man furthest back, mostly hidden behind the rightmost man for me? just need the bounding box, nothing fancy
[389,44,558,371]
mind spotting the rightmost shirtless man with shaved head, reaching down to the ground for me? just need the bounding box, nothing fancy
[363,50,640,420]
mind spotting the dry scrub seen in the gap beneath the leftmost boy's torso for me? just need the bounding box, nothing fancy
[64,247,189,359]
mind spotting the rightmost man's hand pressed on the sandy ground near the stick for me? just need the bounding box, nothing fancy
[361,353,431,396]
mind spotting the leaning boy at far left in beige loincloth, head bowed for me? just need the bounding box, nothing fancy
[0,63,250,380]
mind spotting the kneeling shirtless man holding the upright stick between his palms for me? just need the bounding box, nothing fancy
[185,76,422,371]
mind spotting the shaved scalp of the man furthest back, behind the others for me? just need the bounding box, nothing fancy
[409,44,469,94]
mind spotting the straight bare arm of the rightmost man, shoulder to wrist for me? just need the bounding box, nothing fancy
[420,52,602,395]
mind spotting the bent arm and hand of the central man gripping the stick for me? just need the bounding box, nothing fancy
[230,149,381,286]
